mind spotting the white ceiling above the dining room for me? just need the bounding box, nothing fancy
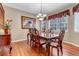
[4,3,72,15]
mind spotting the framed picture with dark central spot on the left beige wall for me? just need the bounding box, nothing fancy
[21,16,35,29]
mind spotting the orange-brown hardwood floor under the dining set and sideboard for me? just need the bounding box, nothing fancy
[0,41,79,56]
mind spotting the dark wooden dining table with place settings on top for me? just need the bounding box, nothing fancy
[39,33,58,56]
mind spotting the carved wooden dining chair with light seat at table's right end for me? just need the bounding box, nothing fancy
[50,30,65,56]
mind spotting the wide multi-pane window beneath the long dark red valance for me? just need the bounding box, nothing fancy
[49,15,68,31]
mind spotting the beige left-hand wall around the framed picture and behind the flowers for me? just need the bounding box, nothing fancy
[3,6,34,41]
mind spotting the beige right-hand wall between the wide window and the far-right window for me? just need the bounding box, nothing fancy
[68,7,79,45]
